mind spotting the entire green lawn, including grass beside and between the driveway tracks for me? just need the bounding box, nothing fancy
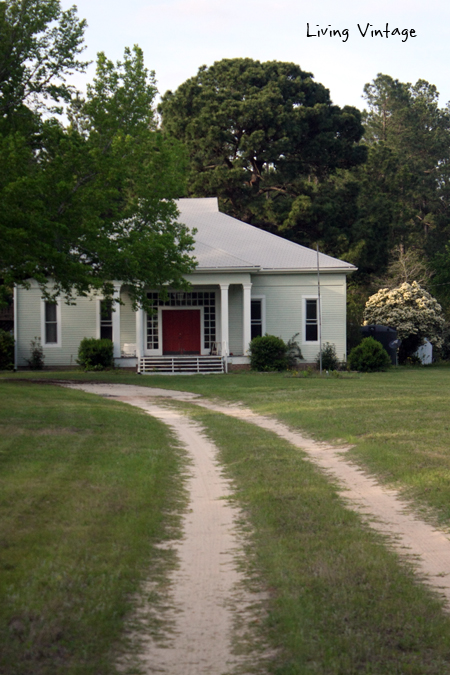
[0,367,450,675]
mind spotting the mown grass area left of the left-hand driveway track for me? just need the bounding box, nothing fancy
[0,382,185,675]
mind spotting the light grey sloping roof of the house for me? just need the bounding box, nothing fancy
[177,197,356,272]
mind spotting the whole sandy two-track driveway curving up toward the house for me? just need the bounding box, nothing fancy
[65,383,450,675]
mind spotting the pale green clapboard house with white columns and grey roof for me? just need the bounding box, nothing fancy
[14,198,356,372]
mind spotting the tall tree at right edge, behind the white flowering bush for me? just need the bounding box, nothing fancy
[355,74,450,274]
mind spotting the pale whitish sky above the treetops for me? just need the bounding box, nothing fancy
[61,0,450,109]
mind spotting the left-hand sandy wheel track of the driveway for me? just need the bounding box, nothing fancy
[72,385,270,675]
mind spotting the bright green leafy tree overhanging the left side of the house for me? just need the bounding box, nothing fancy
[0,0,194,304]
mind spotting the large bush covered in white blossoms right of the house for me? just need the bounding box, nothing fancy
[364,281,444,362]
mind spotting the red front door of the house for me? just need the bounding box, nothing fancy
[162,309,201,354]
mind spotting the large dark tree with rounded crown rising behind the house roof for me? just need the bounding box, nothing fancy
[159,59,366,248]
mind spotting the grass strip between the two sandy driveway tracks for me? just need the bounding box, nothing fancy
[184,406,450,675]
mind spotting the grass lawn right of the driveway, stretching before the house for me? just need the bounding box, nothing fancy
[5,366,450,526]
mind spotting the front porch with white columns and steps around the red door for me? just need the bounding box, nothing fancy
[110,274,254,372]
